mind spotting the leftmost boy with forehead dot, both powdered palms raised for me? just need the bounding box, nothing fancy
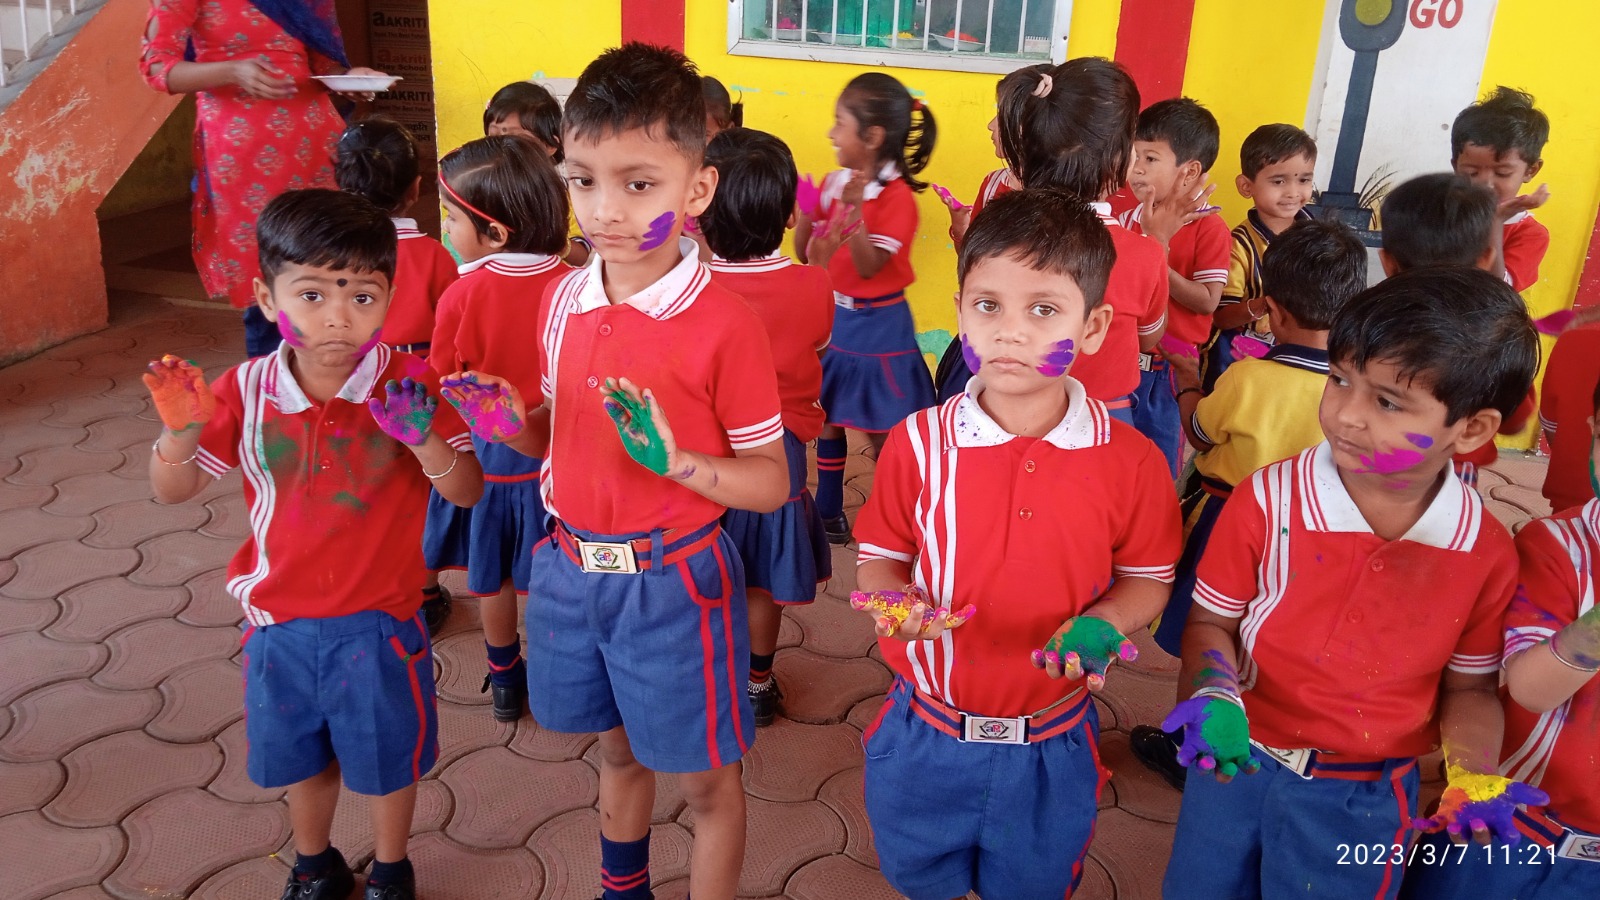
[144,184,483,900]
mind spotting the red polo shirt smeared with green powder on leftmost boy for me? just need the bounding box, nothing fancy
[198,344,472,625]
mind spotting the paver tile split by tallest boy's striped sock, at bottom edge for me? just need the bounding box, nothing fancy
[528,809,691,900]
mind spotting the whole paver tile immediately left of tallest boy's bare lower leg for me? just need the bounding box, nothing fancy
[438,746,600,849]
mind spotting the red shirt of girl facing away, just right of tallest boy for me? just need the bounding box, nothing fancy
[710,253,835,442]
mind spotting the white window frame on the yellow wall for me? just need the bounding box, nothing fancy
[728,0,1072,75]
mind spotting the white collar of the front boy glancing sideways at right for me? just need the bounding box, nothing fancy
[1294,440,1483,551]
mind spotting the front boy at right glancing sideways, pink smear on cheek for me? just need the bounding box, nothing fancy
[1163,267,1539,900]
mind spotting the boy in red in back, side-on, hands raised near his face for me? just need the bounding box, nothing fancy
[1122,98,1230,479]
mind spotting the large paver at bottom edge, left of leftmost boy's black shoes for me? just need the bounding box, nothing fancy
[106,790,290,900]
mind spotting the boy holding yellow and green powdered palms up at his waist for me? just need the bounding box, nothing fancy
[856,187,1179,900]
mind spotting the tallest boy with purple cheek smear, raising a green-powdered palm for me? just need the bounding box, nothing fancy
[446,43,789,900]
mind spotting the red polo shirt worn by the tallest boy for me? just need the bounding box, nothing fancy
[539,239,782,535]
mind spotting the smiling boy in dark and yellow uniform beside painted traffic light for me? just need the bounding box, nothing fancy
[1202,123,1317,391]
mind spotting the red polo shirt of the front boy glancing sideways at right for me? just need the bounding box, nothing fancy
[1195,444,1517,759]
